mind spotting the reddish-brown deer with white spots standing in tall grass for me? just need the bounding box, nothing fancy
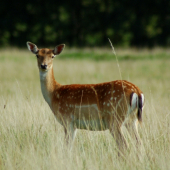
[26,42,144,152]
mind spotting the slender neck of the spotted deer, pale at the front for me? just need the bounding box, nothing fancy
[39,68,59,108]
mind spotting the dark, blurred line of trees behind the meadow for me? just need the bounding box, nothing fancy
[0,0,170,48]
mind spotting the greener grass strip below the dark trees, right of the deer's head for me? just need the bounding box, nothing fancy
[59,47,170,61]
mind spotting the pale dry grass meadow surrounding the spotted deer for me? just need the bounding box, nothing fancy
[0,48,170,170]
